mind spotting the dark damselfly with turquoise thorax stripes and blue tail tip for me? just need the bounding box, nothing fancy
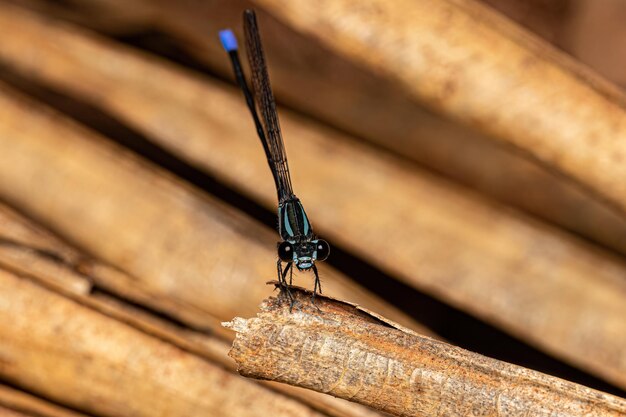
[219,10,330,302]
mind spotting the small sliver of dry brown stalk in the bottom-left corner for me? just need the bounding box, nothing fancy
[0,384,91,417]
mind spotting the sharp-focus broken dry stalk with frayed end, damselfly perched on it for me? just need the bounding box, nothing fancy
[224,289,626,417]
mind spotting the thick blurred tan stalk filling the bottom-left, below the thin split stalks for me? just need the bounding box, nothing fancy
[0,270,336,417]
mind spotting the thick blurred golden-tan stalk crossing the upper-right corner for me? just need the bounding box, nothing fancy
[252,0,626,216]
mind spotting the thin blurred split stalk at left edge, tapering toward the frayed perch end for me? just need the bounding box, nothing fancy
[0,200,232,340]
